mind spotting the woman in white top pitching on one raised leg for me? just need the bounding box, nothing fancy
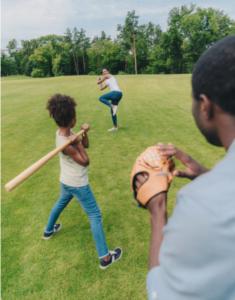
[97,68,122,131]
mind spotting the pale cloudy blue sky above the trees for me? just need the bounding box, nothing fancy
[1,0,235,49]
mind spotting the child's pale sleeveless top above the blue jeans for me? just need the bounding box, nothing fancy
[56,129,88,187]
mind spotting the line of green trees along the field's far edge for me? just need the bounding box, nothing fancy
[1,4,235,77]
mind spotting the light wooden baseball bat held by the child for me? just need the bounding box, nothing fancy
[5,130,85,192]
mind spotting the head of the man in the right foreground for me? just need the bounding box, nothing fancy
[192,36,235,146]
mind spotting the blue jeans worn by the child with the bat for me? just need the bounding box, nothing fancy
[45,182,109,258]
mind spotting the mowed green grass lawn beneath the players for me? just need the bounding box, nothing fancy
[2,75,224,300]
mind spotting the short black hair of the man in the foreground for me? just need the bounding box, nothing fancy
[192,36,235,115]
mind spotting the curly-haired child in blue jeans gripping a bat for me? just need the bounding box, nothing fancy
[43,94,122,269]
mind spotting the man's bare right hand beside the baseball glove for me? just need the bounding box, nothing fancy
[157,143,209,180]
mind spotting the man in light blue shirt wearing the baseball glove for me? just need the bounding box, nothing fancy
[135,36,235,300]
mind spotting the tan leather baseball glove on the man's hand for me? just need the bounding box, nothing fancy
[131,146,175,208]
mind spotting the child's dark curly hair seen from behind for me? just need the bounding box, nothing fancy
[46,94,77,127]
